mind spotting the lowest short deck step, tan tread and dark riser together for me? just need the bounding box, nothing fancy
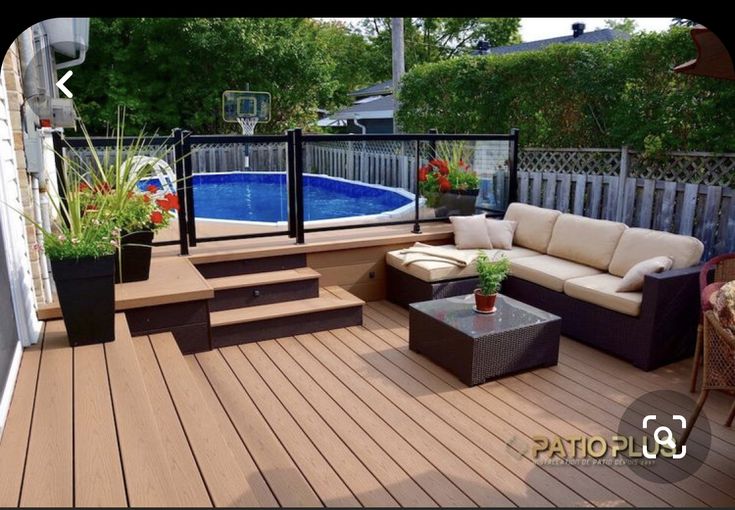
[210,287,364,347]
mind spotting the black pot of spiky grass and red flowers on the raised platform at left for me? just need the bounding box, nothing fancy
[65,110,179,283]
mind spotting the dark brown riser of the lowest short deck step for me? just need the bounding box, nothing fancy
[212,305,362,348]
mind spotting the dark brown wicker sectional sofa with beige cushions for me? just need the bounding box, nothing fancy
[386,203,703,370]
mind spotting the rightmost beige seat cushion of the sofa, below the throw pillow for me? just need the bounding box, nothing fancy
[564,273,643,317]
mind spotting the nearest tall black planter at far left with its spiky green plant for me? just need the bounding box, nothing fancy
[29,159,118,346]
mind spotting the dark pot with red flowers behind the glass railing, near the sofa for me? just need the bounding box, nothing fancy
[418,142,479,217]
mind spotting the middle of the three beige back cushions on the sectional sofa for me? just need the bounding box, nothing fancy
[546,214,628,271]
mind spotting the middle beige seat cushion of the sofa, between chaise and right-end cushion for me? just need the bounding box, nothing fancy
[510,255,600,292]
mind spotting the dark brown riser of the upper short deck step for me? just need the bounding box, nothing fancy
[209,278,319,312]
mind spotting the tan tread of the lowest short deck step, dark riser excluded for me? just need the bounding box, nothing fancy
[210,287,365,328]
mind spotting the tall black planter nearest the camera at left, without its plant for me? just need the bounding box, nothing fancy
[51,255,115,347]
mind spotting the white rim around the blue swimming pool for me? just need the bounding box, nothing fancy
[192,172,426,229]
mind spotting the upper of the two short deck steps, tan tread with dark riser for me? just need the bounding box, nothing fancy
[207,267,321,312]
